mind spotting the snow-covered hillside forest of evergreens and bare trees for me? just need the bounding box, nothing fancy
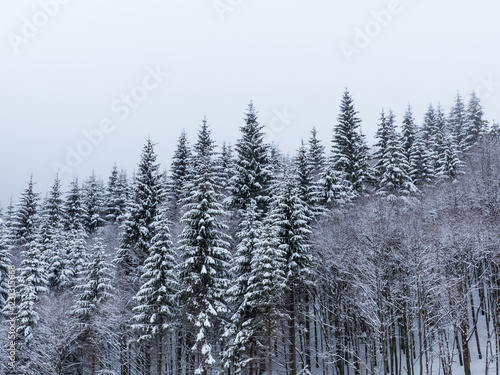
[0,90,500,375]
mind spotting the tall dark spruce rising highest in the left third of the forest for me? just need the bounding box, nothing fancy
[117,139,165,273]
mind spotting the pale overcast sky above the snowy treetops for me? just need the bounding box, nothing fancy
[0,0,500,206]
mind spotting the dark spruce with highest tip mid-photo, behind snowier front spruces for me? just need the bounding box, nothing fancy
[231,102,271,211]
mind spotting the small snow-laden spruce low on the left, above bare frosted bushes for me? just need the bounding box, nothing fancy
[73,234,114,324]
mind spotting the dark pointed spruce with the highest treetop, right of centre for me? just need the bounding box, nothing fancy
[330,89,368,193]
